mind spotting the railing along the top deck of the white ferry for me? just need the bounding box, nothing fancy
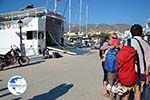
[0,7,64,22]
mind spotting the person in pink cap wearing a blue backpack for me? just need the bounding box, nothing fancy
[100,33,120,96]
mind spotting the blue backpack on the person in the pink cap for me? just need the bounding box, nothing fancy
[104,49,118,72]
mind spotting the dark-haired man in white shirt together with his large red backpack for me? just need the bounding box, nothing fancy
[116,24,150,100]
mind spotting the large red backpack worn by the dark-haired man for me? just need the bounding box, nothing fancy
[116,45,137,86]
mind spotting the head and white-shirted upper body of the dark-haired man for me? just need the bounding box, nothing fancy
[130,24,150,80]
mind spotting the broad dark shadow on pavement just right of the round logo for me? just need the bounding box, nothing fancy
[29,83,73,100]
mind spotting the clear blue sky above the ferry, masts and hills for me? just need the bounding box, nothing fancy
[0,0,150,25]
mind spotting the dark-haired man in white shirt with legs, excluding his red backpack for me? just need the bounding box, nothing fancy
[124,24,150,100]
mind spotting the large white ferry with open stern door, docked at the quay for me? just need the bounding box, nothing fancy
[0,7,64,56]
